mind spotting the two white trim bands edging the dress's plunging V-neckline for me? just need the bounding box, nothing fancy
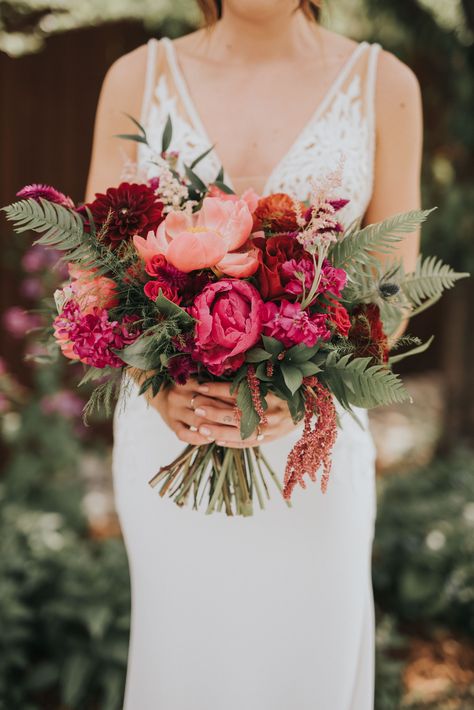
[161,37,368,195]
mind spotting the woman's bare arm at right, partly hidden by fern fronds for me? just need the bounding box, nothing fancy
[364,51,423,339]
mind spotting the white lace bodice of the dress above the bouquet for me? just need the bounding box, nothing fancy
[127,37,380,224]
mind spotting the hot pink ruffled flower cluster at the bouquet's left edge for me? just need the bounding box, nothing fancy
[53,300,139,368]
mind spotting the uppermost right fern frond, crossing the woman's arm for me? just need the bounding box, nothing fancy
[329,210,433,272]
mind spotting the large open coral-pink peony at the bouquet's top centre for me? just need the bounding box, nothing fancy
[133,197,258,277]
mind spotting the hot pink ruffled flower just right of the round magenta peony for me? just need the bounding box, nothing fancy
[262,300,331,348]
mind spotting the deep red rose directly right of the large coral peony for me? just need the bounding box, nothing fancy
[253,234,304,301]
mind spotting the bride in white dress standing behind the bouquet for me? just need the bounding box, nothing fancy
[86,0,422,710]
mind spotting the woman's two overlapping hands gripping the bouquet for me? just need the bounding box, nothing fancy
[145,380,295,449]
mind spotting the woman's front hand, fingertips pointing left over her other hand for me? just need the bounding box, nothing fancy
[193,382,296,449]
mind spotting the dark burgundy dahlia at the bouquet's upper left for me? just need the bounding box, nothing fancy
[85,182,163,247]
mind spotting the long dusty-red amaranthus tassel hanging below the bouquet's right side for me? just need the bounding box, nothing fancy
[283,377,337,500]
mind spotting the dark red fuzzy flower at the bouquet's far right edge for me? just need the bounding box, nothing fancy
[349,303,389,363]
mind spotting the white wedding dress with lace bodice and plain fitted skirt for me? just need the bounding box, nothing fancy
[113,39,379,710]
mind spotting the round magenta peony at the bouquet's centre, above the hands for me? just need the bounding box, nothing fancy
[190,279,263,375]
